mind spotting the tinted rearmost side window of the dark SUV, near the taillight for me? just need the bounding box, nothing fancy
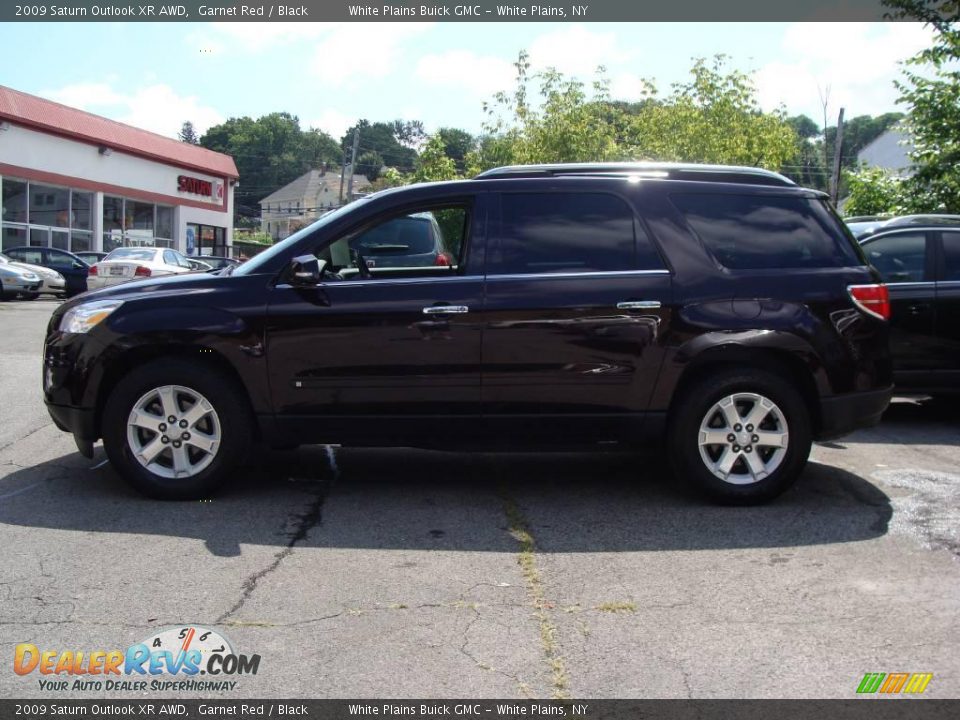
[671,193,860,270]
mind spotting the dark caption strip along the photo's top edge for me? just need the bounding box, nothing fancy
[0,0,908,22]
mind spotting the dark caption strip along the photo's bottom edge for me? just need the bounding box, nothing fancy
[0,696,960,720]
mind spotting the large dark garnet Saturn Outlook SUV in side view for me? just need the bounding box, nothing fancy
[43,164,892,503]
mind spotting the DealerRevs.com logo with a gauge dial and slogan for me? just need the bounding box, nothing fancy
[13,625,260,692]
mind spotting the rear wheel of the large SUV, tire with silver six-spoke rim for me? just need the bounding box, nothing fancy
[668,368,812,505]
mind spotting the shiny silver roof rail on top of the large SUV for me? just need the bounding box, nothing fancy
[476,162,796,187]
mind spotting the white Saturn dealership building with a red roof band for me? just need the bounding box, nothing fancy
[0,85,238,255]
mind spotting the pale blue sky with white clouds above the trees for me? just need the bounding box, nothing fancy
[0,22,931,139]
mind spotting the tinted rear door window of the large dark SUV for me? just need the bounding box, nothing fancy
[489,193,663,275]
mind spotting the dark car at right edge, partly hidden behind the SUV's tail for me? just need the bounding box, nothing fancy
[859,215,960,395]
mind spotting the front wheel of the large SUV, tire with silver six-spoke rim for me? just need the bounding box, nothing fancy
[103,359,253,500]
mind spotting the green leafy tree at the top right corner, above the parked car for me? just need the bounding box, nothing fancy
[885,0,960,212]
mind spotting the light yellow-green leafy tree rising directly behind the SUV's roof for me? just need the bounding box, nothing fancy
[465,53,799,172]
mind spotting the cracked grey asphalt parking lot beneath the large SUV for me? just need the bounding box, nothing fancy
[0,300,960,698]
